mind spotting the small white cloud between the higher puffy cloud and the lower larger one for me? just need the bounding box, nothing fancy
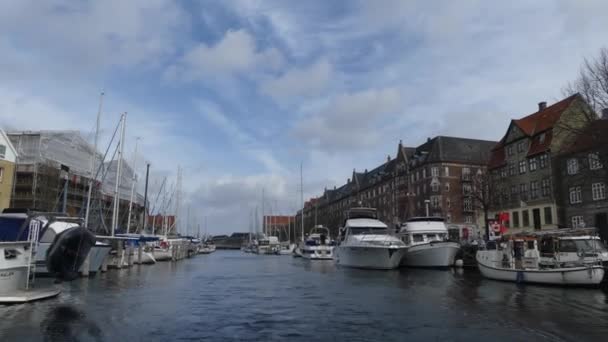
[261,59,332,102]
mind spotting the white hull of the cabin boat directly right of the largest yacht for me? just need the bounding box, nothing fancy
[401,242,460,267]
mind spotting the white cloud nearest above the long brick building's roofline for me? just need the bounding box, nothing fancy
[294,88,401,151]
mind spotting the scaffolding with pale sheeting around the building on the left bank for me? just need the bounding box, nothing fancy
[7,131,143,231]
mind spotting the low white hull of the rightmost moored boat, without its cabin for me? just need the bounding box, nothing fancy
[477,251,605,286]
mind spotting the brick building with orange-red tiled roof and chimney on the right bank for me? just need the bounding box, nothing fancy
[488,94,590,230]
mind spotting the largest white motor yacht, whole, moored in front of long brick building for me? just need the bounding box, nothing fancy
[334,208,407,270]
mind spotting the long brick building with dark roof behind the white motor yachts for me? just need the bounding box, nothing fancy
[296,136,496,240]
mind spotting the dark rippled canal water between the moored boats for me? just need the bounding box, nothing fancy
[0,251,608,342]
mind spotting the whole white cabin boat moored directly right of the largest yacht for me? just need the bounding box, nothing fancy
[399,217,460,267]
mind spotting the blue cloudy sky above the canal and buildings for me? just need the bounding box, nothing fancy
[0,0,608,234]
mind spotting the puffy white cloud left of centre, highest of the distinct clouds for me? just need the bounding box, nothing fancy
[167,30,283,81]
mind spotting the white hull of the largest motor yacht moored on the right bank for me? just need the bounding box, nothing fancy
[334,246,406,270]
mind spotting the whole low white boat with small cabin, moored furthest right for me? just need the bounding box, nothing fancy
[476,236,605,286]
